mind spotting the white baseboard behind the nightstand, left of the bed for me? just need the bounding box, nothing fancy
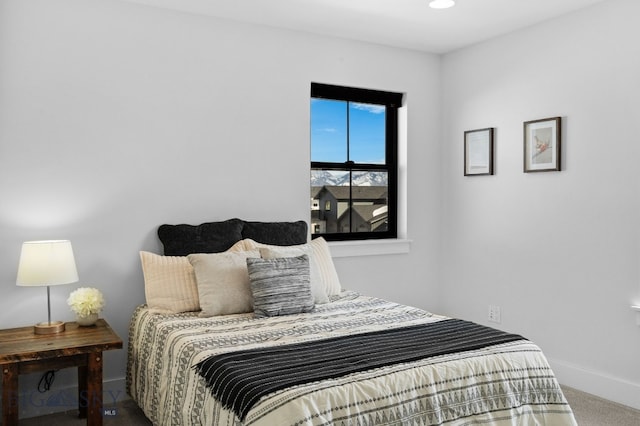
[4,377,129,419]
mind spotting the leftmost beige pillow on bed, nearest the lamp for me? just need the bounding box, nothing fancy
[140,251,200,314]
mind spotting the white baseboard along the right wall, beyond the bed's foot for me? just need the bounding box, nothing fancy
[549,359,640,410]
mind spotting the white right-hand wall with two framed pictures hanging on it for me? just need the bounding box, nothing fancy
[441,0,640,408]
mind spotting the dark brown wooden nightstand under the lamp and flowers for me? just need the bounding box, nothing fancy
[0,319,122,426]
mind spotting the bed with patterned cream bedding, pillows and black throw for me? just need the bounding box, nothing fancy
[127,219,576,426]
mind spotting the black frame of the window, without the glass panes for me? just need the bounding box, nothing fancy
[311,82,404,241]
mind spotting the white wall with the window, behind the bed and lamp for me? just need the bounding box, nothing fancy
[0,0,440,415]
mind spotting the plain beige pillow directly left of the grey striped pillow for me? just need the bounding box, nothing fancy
[187,250,260,317]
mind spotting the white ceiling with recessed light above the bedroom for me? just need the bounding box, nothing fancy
[125,0,605,53]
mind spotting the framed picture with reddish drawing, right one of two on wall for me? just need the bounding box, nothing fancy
[524,117,562,173]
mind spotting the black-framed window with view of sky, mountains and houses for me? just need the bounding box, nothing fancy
[311,83,402,241]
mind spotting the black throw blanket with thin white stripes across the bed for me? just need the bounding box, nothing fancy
[194,319,524,420]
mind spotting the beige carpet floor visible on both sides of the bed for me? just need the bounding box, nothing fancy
[20,387,640,426]
